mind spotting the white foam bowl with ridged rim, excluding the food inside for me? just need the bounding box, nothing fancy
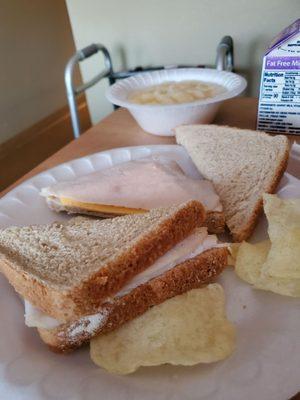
[106,68,247,136]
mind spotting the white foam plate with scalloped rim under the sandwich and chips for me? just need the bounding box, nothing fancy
[0,145,300,400]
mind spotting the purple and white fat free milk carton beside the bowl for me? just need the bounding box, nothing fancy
[257,19,300,135]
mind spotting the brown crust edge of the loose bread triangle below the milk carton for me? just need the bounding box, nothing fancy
[232,138,290,242]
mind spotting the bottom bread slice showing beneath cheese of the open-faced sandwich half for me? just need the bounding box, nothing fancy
[46,197,225,233]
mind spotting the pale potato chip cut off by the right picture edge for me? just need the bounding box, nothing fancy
[262,194,300,279]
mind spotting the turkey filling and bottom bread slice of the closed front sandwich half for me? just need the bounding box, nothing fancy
[34,228,227,352]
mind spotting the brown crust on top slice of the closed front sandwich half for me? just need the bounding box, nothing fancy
[0,201,205,322]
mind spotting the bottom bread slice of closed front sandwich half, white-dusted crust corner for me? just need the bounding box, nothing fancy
[38,247,228,352]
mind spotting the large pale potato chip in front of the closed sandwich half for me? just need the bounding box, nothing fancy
[91,284,235,374]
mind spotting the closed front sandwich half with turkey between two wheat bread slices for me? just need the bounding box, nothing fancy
[0,201,227,352]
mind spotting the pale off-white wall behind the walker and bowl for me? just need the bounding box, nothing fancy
[66,0,299,123]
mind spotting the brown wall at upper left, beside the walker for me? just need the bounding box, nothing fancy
[0,0,79,143]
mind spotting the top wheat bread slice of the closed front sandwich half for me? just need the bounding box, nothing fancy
[0,201,205,321]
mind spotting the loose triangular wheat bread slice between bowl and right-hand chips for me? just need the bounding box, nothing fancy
[175,125,289,242]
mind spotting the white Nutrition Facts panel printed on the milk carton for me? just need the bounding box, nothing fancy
[257,69,300,134]
